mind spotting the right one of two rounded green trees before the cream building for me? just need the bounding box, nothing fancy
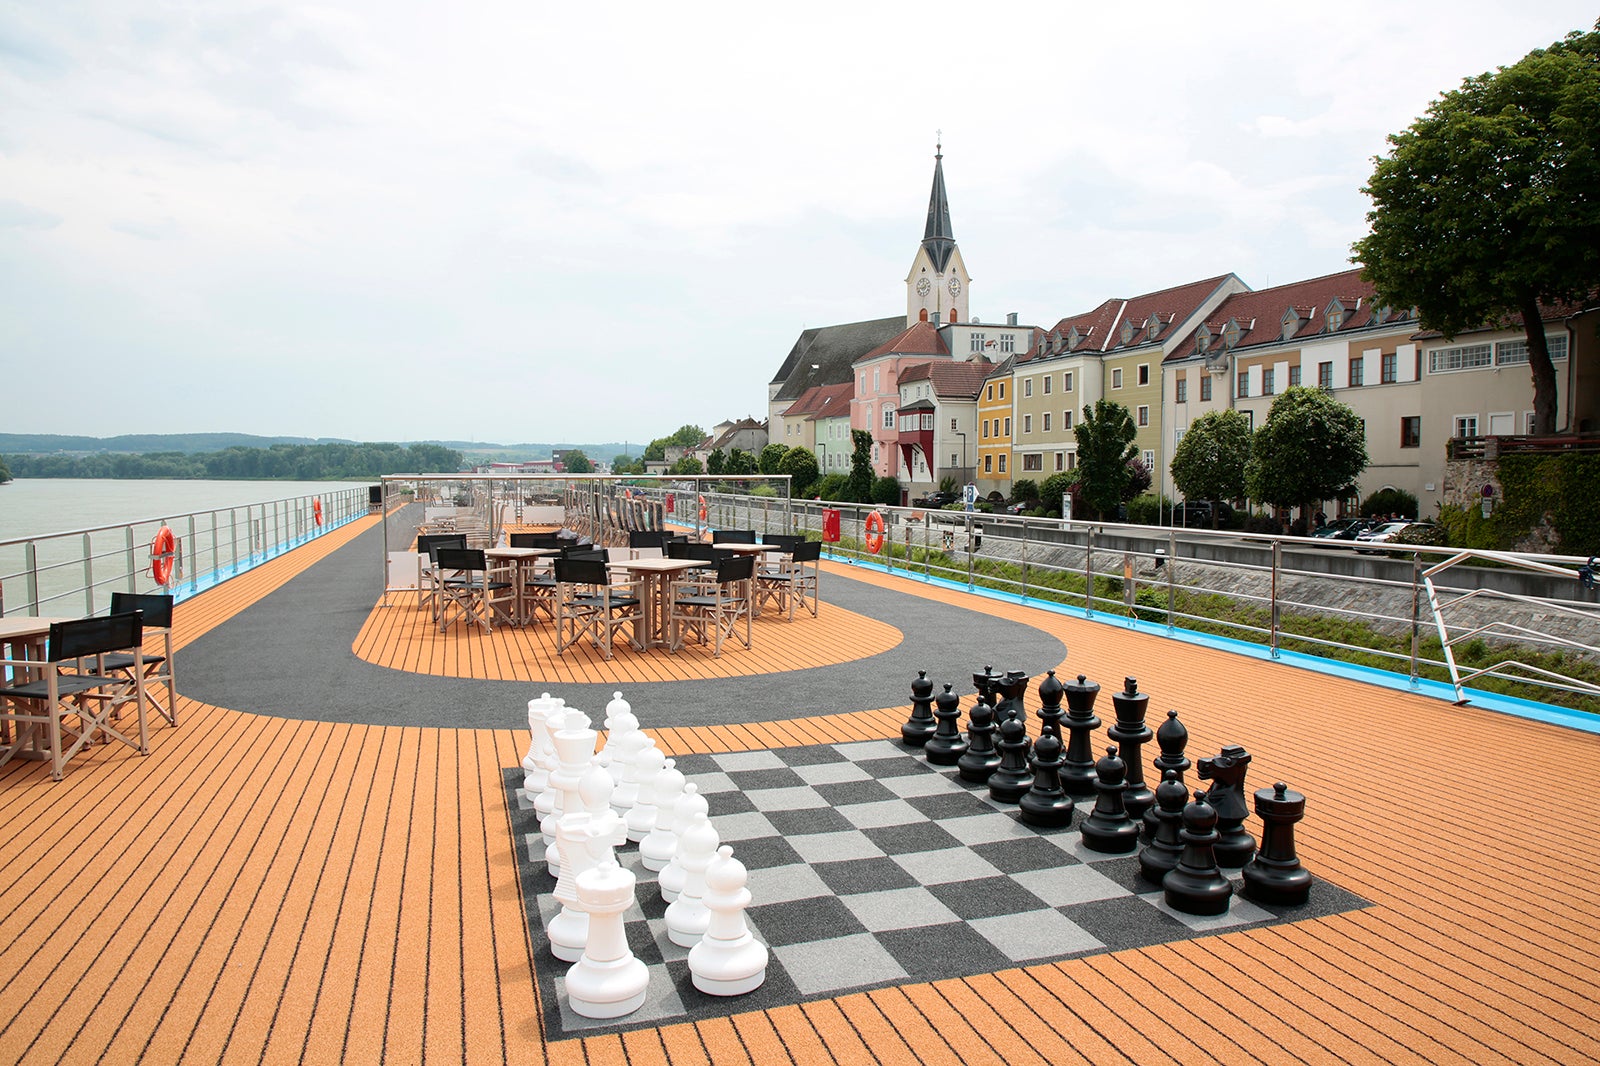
[1245,386,1366,527]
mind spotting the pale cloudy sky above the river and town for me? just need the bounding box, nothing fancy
[0,0,1595,443]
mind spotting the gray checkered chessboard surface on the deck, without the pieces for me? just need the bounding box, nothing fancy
[506,739,1366,1040]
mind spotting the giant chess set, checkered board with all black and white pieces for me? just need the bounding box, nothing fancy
[506,667,1365,1039]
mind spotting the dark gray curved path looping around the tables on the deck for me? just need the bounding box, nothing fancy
[178,512,1067,728]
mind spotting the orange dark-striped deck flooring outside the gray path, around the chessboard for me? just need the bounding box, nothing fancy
[0,520,1600,1066]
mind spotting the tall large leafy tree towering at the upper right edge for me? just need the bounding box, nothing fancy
[1354,22,1600,434]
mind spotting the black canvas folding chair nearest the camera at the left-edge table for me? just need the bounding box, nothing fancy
[0,611,150,781]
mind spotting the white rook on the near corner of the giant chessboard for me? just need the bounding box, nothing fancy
[566,866,650,1018]
